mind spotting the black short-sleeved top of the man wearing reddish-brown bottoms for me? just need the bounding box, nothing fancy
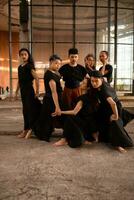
[59,64,87,89]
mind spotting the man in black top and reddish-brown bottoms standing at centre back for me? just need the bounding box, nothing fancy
[59,48,87,109]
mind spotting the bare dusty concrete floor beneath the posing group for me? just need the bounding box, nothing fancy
[0,101,134,200]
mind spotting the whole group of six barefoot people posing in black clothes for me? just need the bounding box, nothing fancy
[16,48,134,152]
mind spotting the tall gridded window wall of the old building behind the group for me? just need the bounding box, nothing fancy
[0,0,134,95]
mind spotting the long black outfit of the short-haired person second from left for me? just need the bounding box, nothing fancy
[34,70,62,142]
